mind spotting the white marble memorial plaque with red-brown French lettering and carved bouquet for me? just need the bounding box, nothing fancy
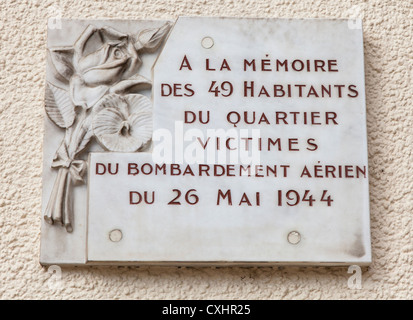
[41,17,371,265]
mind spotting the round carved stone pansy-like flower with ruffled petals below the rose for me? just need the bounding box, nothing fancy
[92,94,152,152]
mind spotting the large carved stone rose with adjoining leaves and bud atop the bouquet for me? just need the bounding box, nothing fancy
[49,23,170,109]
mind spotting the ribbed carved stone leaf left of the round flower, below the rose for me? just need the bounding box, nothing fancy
[45,83,76,129]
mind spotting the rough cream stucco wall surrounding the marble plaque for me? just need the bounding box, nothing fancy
[0,0,413,299]
